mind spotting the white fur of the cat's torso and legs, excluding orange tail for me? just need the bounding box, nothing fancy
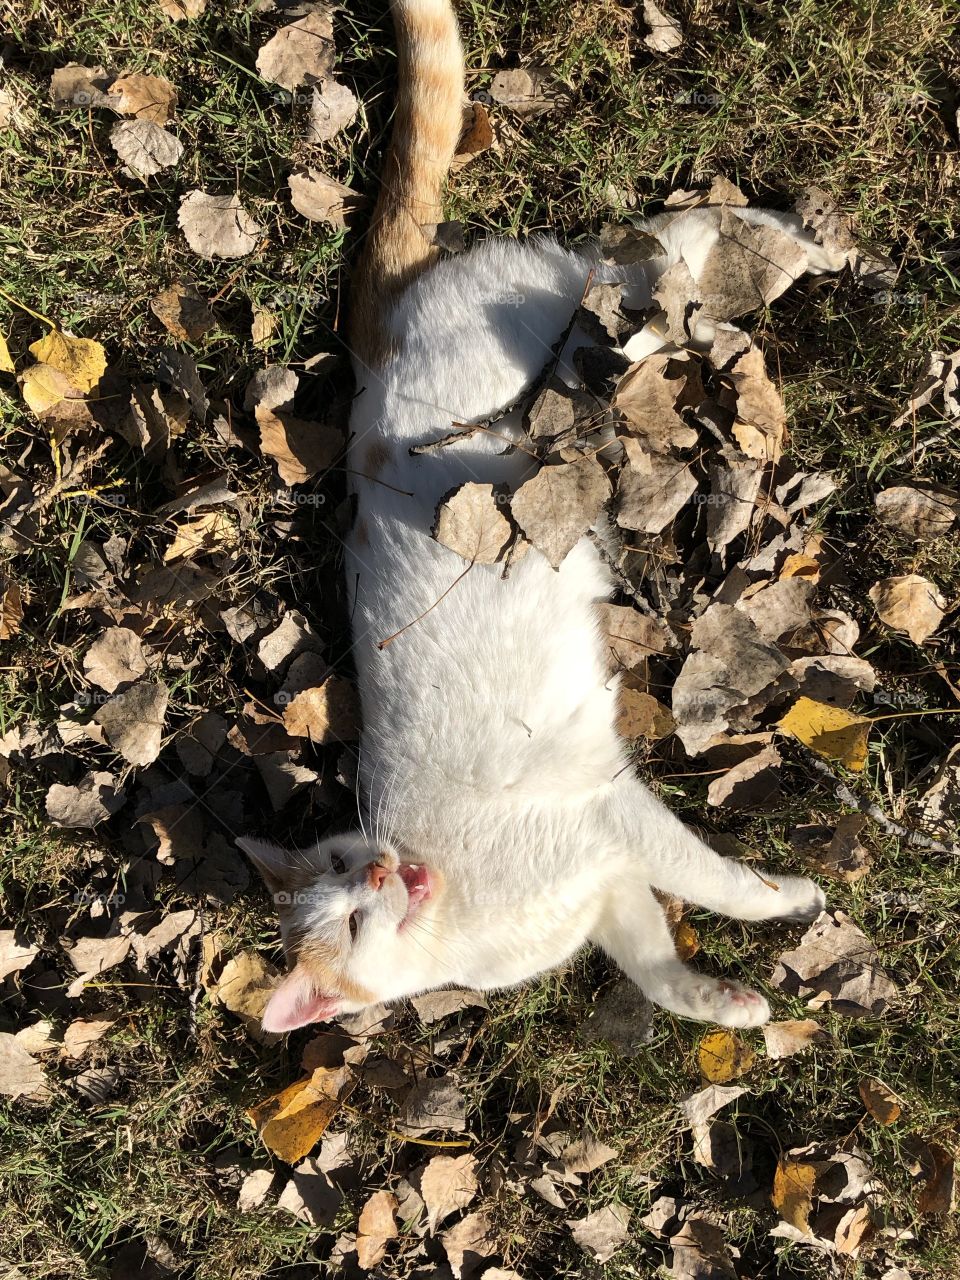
[252,210,838,1025]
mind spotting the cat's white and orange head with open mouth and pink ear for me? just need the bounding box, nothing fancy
[237,832,438,1032]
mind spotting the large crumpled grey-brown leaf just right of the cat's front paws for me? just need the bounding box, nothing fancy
[771,911,897,1018]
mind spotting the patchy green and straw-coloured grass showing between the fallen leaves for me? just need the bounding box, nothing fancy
[0,0,960,1280]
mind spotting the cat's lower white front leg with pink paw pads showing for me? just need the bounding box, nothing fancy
[590,881,771,1027]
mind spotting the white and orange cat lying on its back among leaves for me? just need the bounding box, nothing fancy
[232,0,841,1032]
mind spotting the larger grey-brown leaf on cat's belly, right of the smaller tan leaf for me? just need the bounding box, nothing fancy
[511,458,611,568]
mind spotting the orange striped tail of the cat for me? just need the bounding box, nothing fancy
[349,0,463,365]
